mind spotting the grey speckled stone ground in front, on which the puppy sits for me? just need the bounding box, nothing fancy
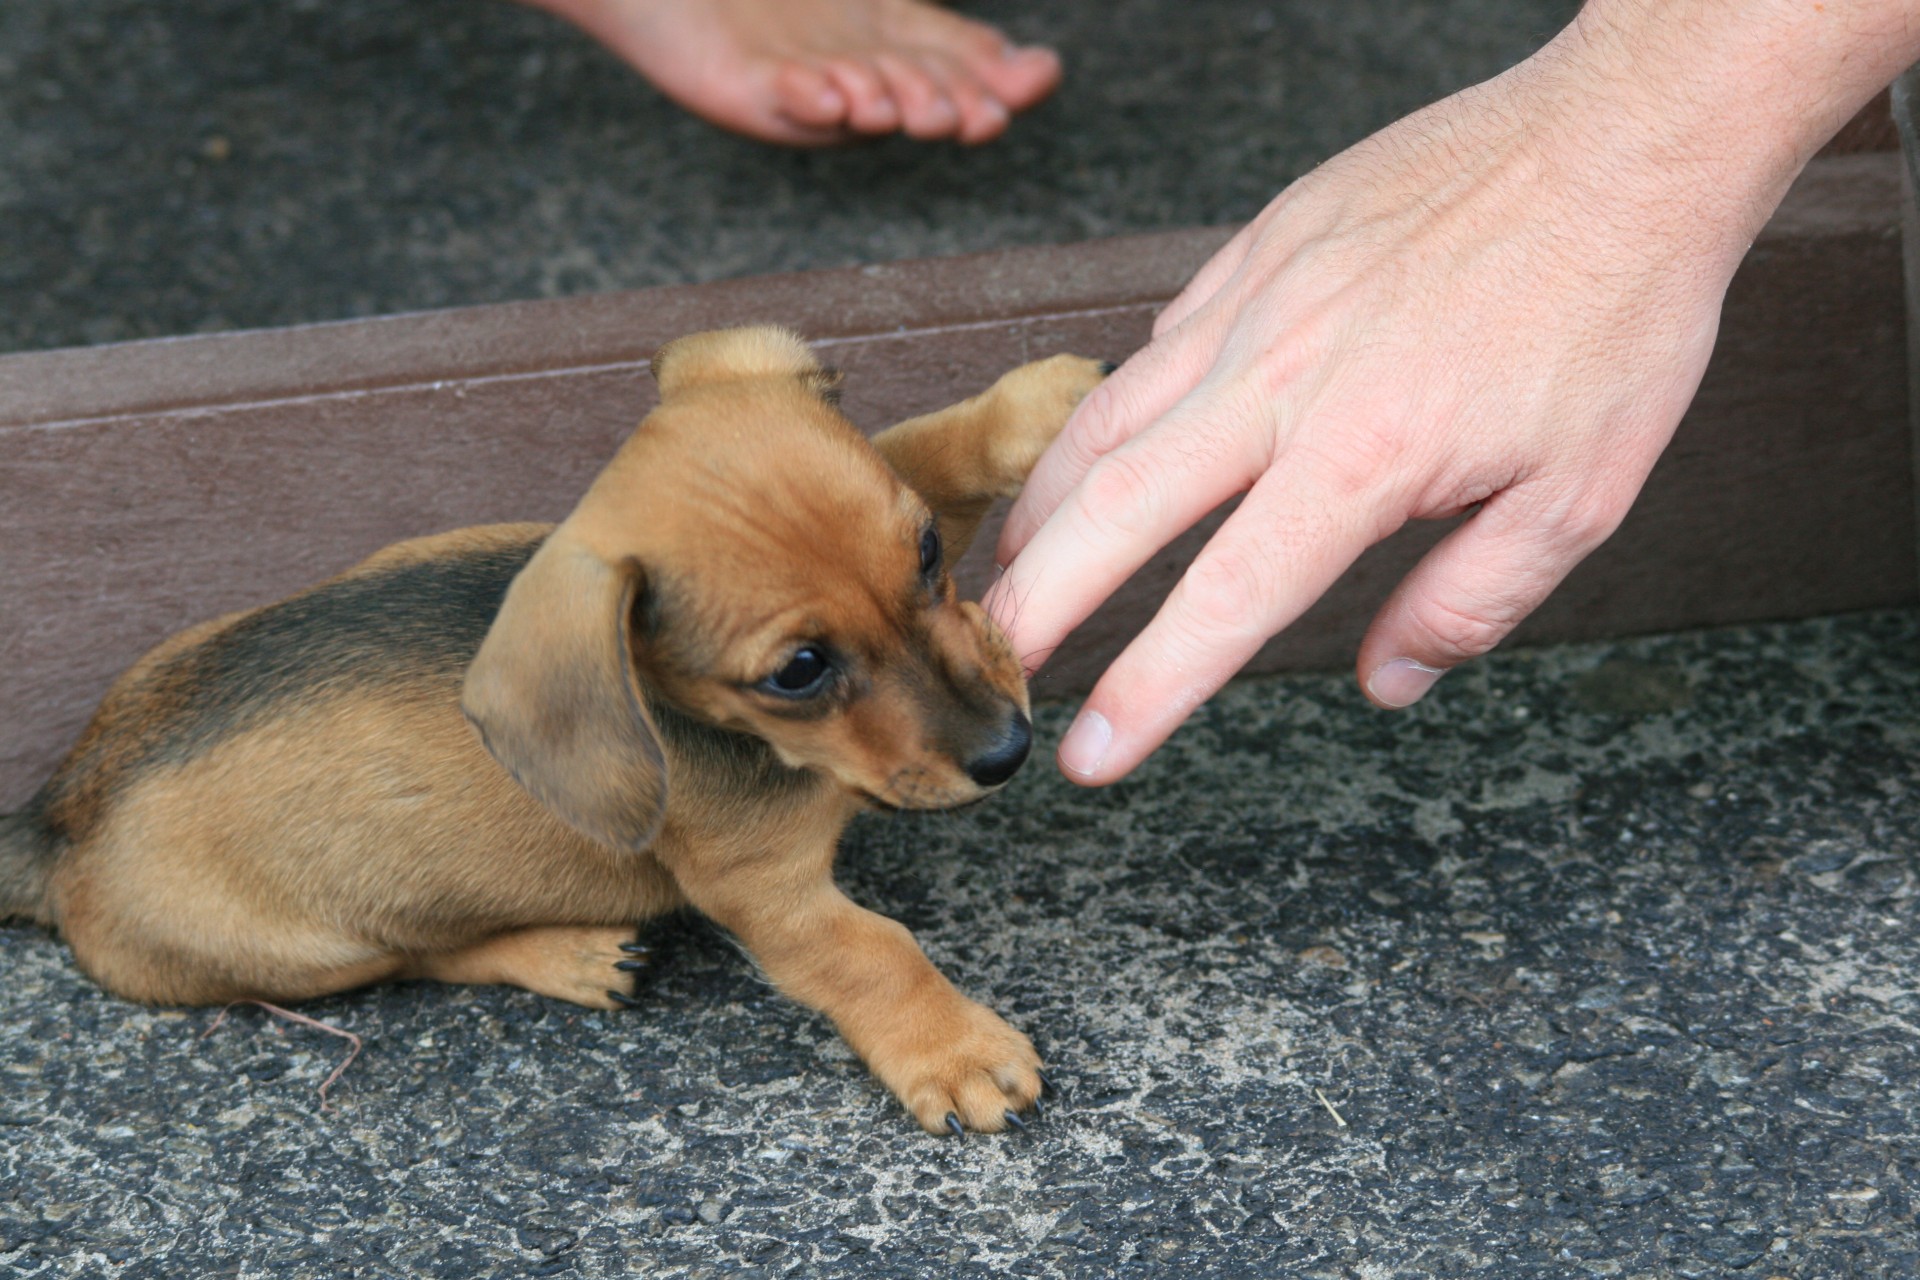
[0,612,1920,1280]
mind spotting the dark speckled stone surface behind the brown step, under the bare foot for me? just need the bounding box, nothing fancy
[0,0,1578,351]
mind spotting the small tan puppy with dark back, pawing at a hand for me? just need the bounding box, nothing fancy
[0,328,1102,1132]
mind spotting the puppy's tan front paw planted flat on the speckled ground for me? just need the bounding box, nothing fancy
[868,998,1043,1134]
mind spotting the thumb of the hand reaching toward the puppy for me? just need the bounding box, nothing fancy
[1357,487,1628,708]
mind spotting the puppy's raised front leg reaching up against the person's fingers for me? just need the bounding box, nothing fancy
[874,355,1112,564]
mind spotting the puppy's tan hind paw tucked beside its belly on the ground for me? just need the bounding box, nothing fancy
[401,925,647,1009]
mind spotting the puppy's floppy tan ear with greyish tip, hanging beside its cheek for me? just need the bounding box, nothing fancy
[461,528,666,848]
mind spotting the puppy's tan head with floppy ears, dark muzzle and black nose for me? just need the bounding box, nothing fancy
[465,328,1031,846]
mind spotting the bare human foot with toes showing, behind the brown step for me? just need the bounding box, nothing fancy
[526,0,1060,146]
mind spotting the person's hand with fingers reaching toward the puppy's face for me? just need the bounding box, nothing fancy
[987,17,1807,785]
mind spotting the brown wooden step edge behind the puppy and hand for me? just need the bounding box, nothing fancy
[0,154,1920,812]
